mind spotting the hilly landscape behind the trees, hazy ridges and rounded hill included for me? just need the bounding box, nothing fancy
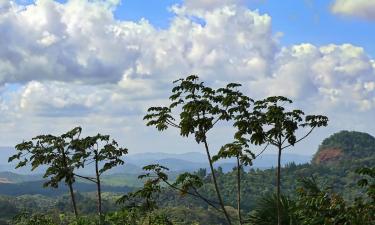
[0,131,375,225]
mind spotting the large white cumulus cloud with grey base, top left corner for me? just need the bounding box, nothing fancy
[0,0,145,83]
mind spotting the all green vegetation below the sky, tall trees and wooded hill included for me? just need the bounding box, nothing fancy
[0,76,375,225]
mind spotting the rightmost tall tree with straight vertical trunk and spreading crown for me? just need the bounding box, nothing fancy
[235,96,328,225]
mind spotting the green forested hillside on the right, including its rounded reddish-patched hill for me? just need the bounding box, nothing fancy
[153,131,375,211]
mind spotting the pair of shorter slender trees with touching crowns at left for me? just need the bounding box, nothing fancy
[9,127,128,220]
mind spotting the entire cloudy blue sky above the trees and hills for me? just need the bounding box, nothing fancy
[0,0,375,155]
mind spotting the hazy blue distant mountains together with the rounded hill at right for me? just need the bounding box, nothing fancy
[0,131,375,196]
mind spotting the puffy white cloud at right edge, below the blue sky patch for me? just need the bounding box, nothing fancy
[252,44,375,111]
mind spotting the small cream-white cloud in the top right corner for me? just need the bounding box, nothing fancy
[331,0,375,20]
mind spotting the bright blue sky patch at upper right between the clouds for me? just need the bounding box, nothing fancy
[258,0,375,56]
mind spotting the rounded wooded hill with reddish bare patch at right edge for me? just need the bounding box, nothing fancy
[312,131,375,164]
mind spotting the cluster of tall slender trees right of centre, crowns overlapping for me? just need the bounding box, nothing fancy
[145,75,328,225]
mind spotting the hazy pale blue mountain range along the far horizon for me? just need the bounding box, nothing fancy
[0,147,312,176]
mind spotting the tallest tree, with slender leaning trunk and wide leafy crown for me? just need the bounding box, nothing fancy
[144,75,250,225]
